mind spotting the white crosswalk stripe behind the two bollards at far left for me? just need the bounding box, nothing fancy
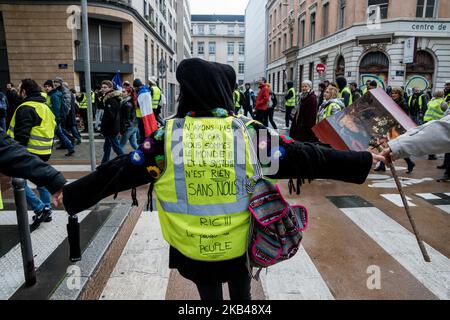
[0,211,90,300]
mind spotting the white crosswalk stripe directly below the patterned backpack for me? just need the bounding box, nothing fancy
[261,246,334,300]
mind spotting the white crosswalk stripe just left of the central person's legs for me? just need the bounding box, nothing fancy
[101,212,170,300]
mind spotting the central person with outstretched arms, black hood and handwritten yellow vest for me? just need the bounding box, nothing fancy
[63,59,382,300]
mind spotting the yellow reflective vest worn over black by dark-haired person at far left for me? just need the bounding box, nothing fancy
[7,101,56,156]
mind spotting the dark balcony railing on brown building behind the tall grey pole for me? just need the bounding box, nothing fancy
[75,43,129,63]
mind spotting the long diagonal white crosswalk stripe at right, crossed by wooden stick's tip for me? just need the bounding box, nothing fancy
[340,207,450,300]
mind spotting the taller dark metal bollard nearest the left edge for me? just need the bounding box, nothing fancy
[12,178,36,286]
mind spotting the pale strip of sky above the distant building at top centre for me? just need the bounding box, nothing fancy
[189,0,248,15]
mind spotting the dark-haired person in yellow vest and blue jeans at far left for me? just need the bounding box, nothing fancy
[7,79,56,229]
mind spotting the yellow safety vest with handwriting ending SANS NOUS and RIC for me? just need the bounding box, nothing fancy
[155,117,257,261]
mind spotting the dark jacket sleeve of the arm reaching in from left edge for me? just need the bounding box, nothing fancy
[0,129,67,193]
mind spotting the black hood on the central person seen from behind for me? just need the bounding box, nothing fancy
[177,58,236,118]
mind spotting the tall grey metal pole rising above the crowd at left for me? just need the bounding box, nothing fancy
[81,0,97,171]
